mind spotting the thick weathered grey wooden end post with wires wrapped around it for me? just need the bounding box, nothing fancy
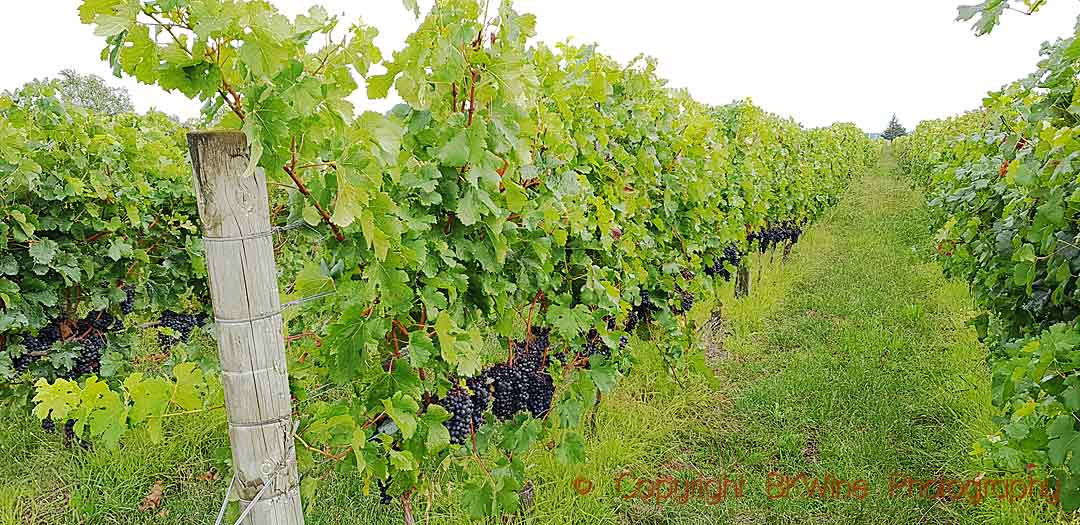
[188,131,303,525]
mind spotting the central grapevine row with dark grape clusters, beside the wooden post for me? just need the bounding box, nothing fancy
[12,0,874,517]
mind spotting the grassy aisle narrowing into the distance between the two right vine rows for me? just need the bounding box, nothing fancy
[518,157,1056,524]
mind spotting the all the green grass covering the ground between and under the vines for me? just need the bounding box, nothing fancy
[0,156,1066,525]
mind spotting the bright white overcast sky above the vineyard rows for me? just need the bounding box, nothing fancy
[0,0,1080,131]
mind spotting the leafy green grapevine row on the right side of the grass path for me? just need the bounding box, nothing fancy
[893,1,1080,510]
